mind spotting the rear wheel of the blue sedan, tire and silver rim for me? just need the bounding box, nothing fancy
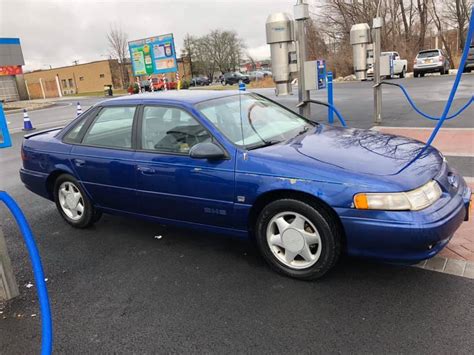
[54,174,102,229]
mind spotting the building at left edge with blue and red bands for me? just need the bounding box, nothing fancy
[0,38,28,102]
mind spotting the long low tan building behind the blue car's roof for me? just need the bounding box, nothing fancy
[24,59,127,99]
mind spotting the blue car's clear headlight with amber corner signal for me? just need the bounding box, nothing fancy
[354,180,443,211]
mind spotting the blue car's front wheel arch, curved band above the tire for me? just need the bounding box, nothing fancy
[248,189,346,249]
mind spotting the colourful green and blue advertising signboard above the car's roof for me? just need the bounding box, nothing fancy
[128,33,178,76]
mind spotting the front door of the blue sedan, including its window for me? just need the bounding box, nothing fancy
[136,106,235,227]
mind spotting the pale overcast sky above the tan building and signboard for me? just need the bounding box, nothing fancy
[0,0,296,70]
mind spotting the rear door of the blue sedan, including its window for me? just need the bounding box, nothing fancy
[70,105,137,212]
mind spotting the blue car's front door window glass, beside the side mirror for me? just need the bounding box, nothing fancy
[141,106,211,154]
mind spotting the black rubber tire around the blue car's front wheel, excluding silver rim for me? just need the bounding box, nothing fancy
[255,199,340,280]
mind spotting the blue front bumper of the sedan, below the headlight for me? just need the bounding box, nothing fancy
[336,179,471,263]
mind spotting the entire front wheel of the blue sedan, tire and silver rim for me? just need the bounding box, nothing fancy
[255,199,342,280]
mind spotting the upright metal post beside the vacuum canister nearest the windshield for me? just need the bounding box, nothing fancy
[294,0,311,119]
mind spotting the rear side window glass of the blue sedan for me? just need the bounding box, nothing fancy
[82,106,136,148]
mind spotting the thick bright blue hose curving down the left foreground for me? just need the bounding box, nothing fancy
[0,190,53,355]
